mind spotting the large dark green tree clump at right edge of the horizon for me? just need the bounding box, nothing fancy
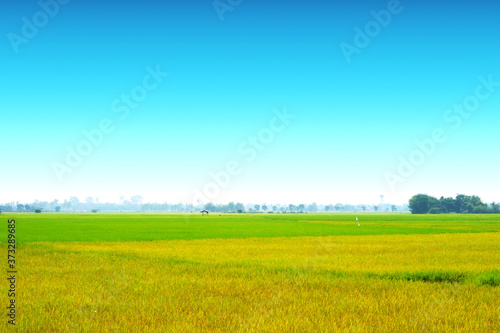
[409,194,500,214]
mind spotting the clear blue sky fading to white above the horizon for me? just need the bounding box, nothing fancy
[0,0,500,203]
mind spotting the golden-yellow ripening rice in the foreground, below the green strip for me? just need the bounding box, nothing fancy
[10,233,500,332]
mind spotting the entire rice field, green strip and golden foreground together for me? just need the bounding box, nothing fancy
[1,214,500,332]
